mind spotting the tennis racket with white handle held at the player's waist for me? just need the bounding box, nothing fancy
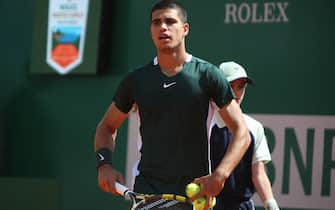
[115,182,193,210]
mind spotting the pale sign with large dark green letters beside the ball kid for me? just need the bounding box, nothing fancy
[253,115,335,210]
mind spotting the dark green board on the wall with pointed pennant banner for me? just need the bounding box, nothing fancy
[30,0,106,75]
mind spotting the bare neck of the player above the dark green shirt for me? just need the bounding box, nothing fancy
[157,51,191,76]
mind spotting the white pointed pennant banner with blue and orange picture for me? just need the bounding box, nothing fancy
[46,0,89,74]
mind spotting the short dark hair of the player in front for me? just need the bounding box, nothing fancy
[150,0,187,23]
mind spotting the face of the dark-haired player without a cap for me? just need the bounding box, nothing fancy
[151,9,189,52]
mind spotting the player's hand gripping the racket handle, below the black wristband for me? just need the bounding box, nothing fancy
[98,164,125,195]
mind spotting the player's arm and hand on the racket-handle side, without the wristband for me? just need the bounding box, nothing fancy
[94,102,128,194]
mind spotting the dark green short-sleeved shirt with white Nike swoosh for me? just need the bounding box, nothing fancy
[113,56,234,177]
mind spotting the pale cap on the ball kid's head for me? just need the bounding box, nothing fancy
[219,61,254,84]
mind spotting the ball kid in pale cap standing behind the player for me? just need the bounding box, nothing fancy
[210,62,279,210]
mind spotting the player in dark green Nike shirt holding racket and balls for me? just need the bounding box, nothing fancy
[94,0,250,209]
